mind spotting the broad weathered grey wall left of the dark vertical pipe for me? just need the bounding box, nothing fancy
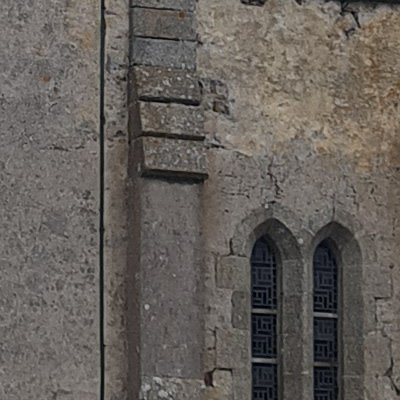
[0,0,99,400]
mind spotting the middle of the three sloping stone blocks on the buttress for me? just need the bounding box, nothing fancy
[139,102,204,139]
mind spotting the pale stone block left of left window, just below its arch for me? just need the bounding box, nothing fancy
[216,256,250,292]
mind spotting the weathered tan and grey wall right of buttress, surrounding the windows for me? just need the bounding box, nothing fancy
[197,0,400,400]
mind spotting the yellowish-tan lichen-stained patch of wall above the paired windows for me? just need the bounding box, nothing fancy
[198,0,400,172]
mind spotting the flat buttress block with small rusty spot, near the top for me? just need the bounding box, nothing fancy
[132,8,196,40]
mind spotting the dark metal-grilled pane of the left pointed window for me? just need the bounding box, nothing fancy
[251,238,278,400]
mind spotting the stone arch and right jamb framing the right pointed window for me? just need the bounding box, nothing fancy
[306,221,365,400]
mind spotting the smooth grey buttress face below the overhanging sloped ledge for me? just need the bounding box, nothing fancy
[137,179,204,378]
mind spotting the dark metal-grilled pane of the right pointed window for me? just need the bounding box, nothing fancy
[314,241,338,400]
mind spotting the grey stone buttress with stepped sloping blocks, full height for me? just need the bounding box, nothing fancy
[128,0,207,399]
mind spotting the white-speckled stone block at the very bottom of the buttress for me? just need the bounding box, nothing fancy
[139,376,203,400]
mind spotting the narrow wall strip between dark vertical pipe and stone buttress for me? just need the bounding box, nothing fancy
[103,0,130,400]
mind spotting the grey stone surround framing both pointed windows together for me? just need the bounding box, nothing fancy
[230,204,365,400]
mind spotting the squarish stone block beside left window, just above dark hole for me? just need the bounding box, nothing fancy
[216,329,251,369]
